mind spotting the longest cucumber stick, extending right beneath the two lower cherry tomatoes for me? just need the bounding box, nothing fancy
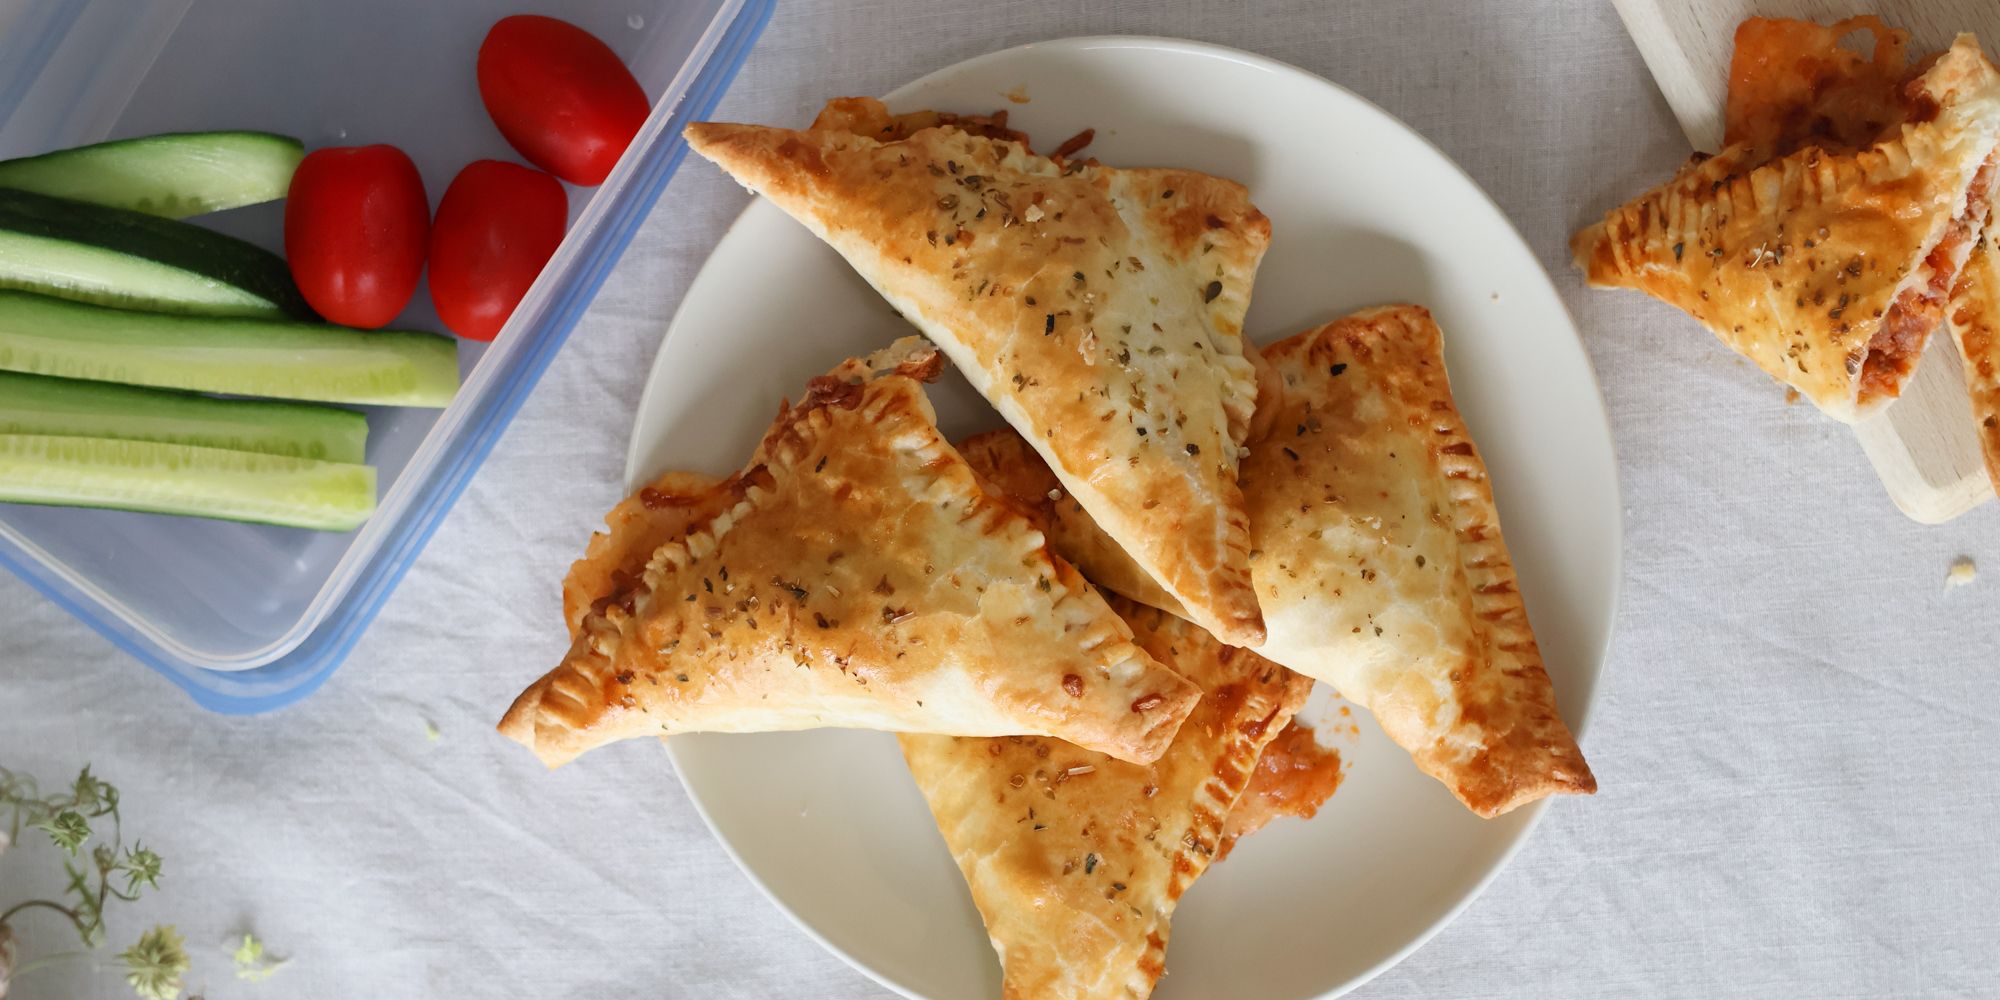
[0,292,458,406]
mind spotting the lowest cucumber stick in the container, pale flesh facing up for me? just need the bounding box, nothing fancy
[0,434,376,532]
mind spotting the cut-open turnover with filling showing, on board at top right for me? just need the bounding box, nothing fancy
[1570,18,2000,422]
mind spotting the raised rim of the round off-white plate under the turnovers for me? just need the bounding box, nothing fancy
[640,34,1624,1000]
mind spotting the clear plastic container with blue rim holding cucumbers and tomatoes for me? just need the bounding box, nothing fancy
[0,0,774,712]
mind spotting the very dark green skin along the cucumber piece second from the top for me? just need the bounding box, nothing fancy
[0,188,318,320]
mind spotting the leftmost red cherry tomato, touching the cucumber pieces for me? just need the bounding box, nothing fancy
[284,146,430,330]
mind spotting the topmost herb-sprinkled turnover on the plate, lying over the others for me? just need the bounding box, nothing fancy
[688,98,1270,646]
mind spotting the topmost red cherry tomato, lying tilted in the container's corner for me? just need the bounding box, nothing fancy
[480,14,652,186]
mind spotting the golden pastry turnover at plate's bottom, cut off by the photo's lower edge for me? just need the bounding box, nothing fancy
[900,598,1312,1000]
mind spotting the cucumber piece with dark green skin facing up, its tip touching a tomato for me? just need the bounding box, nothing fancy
[0,188,314,320]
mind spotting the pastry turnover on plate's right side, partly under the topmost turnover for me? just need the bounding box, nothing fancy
[962,306,1596,816]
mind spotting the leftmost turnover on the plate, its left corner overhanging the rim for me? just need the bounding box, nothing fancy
[500,338,1200,766]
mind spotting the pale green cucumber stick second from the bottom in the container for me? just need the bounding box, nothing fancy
[0,372,368,462]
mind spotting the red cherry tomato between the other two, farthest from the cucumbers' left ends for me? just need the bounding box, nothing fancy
[430,160,570,340]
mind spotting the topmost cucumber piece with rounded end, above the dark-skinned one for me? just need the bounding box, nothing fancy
[0,132,306,218]
